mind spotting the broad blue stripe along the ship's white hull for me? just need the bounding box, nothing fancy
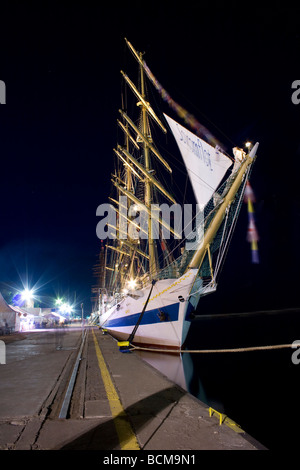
[104,303,179,328]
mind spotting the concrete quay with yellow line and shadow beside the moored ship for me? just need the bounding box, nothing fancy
[0,328,263,452]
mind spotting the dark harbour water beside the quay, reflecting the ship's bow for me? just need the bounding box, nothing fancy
[137,309,300,450]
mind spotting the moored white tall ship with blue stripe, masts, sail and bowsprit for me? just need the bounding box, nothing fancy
[93,39,258,352]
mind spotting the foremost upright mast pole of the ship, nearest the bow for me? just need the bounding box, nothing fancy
[138,53,157,279]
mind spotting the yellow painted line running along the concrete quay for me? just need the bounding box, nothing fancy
[92,330,140,450]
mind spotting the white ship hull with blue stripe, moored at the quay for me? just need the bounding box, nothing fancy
[100,269,200,351]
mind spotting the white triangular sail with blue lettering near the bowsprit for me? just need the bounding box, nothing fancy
[164,114,232,207]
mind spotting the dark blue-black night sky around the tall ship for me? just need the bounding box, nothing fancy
[0,0,300,314]
